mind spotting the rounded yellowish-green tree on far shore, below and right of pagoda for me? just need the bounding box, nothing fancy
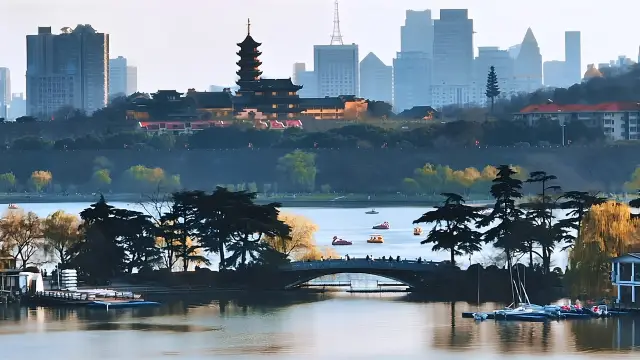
[278,150,318,192]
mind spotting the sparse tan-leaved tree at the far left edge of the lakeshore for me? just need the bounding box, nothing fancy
[0,210,43,269]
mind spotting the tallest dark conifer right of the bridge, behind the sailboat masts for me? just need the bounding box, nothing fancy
[478,165,526,302]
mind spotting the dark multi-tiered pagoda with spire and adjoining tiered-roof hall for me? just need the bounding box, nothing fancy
[234,21,302,120]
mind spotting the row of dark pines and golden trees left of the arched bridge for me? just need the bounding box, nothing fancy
[0,187,336,283]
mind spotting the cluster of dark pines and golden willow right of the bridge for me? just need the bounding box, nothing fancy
[414,165,640,296]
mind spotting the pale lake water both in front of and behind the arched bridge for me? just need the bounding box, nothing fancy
[0,204,640,360]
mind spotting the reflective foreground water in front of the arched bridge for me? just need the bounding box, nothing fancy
[0,294,640,360]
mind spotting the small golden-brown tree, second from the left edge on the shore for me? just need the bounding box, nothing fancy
[43,210,82,265]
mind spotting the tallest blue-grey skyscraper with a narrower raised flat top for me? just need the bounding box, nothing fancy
[433,9,473,86]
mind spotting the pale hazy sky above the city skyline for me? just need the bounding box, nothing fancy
[0,0,640,92]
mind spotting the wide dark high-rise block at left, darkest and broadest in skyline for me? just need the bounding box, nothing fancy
[27,25,109,118]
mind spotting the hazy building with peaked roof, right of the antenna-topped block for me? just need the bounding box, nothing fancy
[360,53,393,104]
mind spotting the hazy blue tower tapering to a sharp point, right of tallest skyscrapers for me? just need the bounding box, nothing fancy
[515,28,542,93]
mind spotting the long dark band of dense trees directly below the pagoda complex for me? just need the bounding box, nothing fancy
[6,119,605,151]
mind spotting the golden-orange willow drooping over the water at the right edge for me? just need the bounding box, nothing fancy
[567,201,640,296]
